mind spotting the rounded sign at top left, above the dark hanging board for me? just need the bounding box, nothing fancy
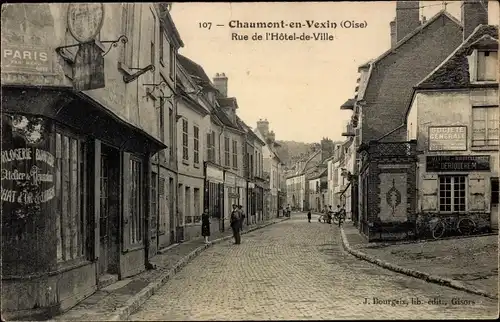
[68,2,104,42]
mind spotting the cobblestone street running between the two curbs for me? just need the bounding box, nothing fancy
[129,214,498,321]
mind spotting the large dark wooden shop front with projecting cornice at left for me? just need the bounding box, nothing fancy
[1,86,164,319]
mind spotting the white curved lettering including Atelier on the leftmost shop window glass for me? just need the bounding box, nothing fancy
[1,148,55,205]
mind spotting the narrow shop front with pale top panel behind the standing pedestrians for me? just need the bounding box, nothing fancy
[204,162,224,232]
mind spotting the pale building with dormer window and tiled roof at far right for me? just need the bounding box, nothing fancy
[406,21,500,230]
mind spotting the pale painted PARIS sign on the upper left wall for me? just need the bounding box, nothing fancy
[2,42,53,74]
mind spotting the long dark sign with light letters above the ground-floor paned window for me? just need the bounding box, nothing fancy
[426,155,490,172]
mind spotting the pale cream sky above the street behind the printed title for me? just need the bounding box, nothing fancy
[171,1,499,143]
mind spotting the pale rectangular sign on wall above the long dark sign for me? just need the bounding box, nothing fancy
[429,126,467,151]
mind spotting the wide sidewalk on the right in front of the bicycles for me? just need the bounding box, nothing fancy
[343,225,498,297]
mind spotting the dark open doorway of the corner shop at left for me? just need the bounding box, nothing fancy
[98,144,121,284]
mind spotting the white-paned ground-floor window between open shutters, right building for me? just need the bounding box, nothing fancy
[439,176,466,212]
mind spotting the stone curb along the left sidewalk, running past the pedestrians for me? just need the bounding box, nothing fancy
[108,218,290,321]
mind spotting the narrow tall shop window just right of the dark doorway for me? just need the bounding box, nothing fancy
[128,159,144,244]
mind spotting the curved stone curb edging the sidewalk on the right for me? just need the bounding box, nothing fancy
[340,228,498,300]
